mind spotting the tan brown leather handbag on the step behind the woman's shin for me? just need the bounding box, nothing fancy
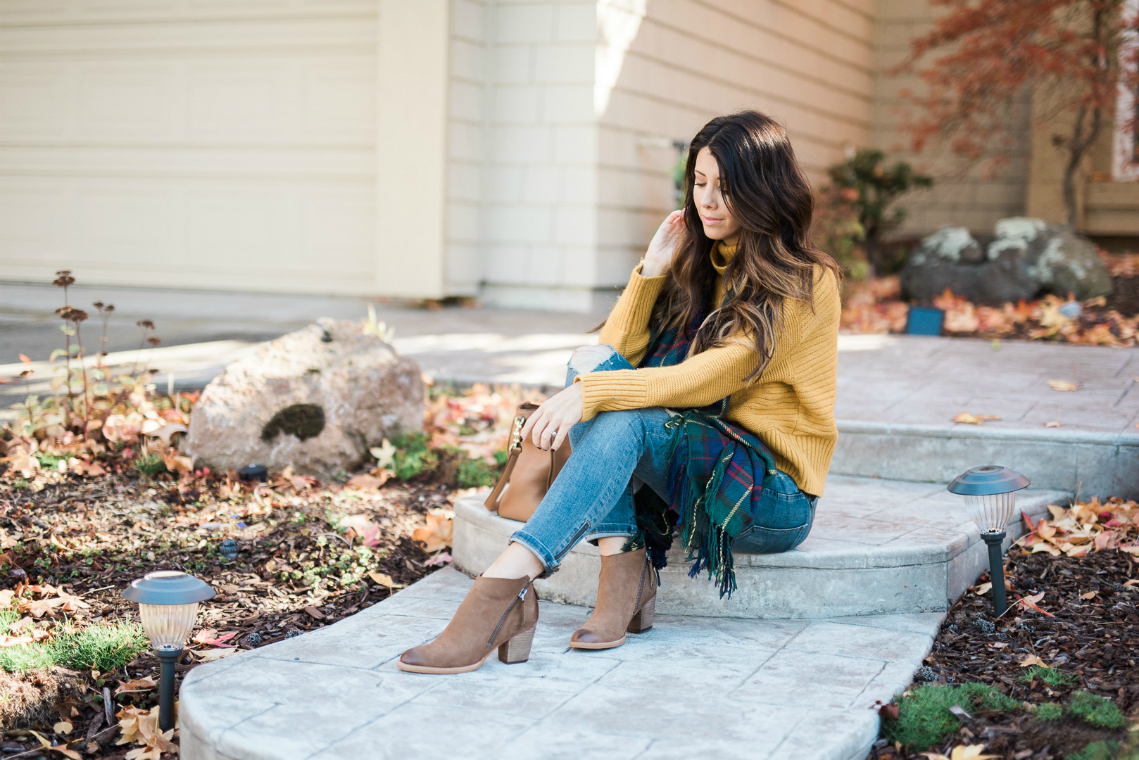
[486,402,570,522]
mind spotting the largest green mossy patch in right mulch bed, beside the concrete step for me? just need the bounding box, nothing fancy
[882,684,1021,752]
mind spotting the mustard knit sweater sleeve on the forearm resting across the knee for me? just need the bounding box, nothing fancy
[577,342,757,420]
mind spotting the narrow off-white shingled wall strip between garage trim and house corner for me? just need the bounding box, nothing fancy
[481,0,598,311]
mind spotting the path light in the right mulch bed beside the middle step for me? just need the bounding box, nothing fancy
[949,465,1030,618]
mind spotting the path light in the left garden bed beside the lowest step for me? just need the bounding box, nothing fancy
[123,570,214,732]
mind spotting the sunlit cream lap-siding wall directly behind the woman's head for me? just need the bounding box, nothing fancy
[596,0,877,296]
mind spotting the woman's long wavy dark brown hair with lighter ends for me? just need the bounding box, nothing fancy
[653,111,842,381]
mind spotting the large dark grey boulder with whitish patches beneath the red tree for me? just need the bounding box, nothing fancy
[901,216,1112,305]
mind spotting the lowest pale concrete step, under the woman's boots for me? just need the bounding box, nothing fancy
[179,569,942,760]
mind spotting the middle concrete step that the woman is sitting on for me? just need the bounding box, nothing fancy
[452,475,1071,619]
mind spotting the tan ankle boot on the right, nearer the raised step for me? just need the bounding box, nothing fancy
[570,549,656,649]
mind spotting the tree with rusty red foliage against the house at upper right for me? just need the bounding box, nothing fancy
[892,0,1139,228]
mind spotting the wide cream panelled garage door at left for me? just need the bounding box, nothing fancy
[0,0,378,294]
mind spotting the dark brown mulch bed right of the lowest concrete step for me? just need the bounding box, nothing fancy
[869,547,1139,760]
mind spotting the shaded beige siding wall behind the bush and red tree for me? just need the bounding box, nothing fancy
[872,0,1031,237]
